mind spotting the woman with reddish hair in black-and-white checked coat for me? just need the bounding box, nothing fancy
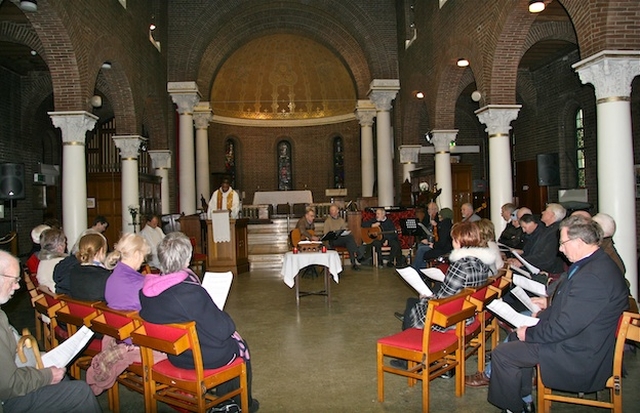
[402,222,496,330]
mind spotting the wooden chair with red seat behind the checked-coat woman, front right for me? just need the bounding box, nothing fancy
[377,289,476,412]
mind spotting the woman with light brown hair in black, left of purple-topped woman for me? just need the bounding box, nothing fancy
[69,232,111,301]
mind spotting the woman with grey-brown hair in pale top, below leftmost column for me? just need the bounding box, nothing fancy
[37,228,67,295]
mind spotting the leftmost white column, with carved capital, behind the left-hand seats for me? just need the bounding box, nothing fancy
[48,111,98,245]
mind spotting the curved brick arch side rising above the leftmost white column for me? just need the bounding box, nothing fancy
[25,0,89,111]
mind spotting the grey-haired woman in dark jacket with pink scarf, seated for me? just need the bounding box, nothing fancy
[140,232,259,412]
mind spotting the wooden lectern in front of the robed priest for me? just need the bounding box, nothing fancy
[207,218,249,275]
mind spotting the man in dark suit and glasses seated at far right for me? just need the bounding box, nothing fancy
[488,216,629,412]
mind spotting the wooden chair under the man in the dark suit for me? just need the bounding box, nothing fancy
[537,312,640,413]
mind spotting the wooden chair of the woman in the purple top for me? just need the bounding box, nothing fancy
[91,303,146,413]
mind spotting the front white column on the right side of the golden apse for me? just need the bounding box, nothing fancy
[369,79,400,206]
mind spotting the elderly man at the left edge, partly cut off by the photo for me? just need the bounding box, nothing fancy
[0,251,102,413]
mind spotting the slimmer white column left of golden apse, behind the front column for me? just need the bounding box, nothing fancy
[193,102,213,204]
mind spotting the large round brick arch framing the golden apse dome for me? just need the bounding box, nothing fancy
[175,2,388,97]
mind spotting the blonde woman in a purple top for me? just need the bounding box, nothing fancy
[104,234,151,311]
